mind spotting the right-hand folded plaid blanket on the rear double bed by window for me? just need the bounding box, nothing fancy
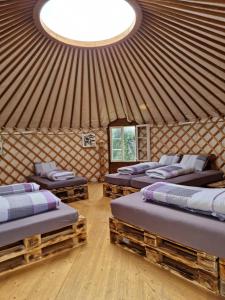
[145,164,194,179]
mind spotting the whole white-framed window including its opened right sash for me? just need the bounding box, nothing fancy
[110,125,150,162]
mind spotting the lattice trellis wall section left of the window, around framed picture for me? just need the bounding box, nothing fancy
[0,129,108,184]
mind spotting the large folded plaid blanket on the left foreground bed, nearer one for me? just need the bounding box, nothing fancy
[0,190,60,222]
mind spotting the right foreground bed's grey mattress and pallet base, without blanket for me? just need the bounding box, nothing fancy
[109,192,225,296]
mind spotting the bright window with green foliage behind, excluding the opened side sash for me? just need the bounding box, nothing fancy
[110,126,136,161]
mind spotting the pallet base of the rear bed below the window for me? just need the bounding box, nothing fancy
[103,182,140,199]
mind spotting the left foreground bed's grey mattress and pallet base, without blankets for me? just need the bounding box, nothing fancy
[0,203,87,275]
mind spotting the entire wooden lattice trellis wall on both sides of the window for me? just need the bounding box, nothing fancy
[0,120,225,184]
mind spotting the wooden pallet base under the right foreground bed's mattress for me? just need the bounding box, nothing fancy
[109,217,225,297]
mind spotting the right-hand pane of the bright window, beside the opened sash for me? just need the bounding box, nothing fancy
[123,126,136,161]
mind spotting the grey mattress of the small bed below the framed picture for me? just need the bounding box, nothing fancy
[27,175,87,190]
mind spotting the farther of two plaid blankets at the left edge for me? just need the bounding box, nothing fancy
[0,182,40,196]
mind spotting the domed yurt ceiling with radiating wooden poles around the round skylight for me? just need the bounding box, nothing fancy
[0,0,225,128]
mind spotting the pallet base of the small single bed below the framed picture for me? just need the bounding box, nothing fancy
[50,184,88,203]
